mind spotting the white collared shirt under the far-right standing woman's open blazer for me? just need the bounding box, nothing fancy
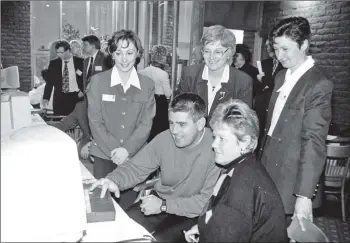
[267,56,315,136]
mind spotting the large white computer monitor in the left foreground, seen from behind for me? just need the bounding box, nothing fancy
[1,125,87,242]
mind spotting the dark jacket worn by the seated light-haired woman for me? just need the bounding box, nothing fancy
[198,153,287,242]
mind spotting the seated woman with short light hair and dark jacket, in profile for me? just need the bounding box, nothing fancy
[185,100,287,242]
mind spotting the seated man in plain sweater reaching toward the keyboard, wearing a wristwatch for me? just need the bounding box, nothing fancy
[90,93,219,242]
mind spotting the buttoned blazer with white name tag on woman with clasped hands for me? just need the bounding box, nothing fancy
[87,69,156,160]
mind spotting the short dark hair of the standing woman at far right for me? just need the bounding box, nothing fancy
[269,17,311,48]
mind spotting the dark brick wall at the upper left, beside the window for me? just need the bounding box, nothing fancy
[1,1,32,92]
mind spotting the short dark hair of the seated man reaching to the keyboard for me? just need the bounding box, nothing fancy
[169,93,207,121]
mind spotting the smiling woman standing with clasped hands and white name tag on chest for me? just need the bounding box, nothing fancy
[87,30,156,179]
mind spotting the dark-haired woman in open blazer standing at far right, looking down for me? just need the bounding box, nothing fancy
[259,17,333,228]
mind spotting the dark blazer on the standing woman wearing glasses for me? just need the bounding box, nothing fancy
[176,64,253,121]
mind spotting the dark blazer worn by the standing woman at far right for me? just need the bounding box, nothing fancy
[258,67,333,214]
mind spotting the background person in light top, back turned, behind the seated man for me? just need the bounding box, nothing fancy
[139,45,172,142]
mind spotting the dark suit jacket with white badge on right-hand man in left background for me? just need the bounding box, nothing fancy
[83,50,113,88]
